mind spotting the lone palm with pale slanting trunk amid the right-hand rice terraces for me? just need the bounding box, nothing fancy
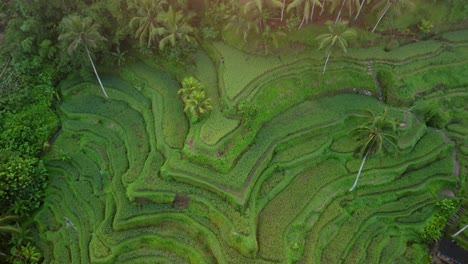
[349,109,398,192]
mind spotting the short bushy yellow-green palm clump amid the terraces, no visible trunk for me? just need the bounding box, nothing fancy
[177,76,213,121]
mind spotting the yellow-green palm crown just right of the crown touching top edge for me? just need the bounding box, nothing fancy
[159,6,195,50]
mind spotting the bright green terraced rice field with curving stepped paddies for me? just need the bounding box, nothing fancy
[35,34,468,263]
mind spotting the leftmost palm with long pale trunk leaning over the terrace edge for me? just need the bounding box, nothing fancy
[58,15,109,98]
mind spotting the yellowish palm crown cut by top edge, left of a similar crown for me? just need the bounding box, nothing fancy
[128,0,167,48]
